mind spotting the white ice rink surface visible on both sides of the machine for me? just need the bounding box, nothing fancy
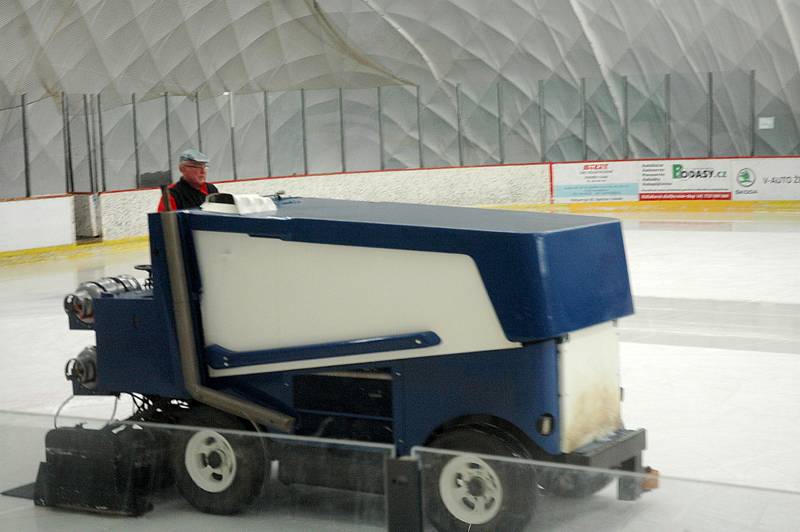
[0,204,800,528]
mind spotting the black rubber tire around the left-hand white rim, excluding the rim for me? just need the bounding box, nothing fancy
[171,407,268,515]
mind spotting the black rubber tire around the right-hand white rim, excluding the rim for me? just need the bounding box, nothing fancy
[422,426,538,532]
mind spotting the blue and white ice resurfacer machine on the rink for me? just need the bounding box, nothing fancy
[43,194,645,531]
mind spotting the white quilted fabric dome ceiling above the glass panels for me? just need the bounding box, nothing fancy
[0,0,800,103]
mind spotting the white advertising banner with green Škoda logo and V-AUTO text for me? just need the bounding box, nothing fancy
[731,157,800,201]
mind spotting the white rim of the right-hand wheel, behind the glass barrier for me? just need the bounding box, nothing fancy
[439,456,503,525]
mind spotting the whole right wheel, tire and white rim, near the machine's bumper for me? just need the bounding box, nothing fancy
[423,427,538,532]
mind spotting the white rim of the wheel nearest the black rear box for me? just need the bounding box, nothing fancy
[184,430,236,493]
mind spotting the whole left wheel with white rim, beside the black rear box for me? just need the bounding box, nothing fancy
[172,407,267,515]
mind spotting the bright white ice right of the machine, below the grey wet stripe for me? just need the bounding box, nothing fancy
[621,343,800,492]
